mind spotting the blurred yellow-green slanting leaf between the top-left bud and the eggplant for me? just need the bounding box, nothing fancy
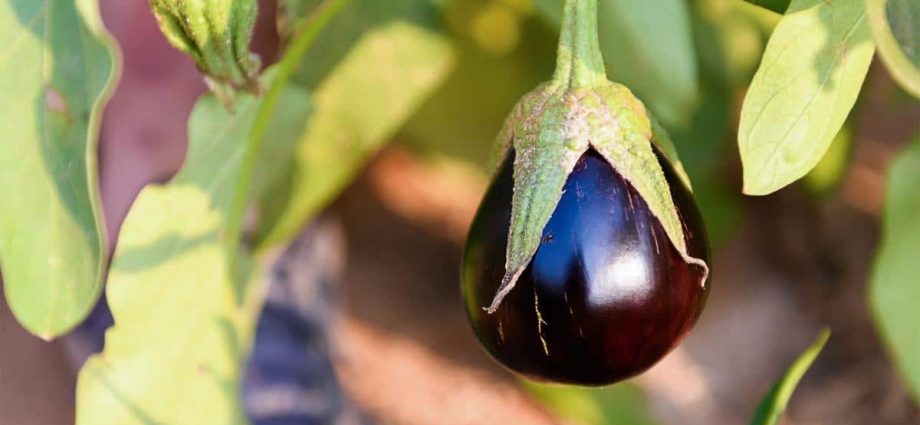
[253,0,453,248]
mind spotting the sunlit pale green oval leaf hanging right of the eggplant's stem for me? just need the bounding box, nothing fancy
[738,0,875,195]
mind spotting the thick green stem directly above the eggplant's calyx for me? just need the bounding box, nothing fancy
[553,0,607,89]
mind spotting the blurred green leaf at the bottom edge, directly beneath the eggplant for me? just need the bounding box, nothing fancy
[521,381,658,425]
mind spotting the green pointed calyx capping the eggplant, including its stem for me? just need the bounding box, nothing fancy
[485,0,709,313]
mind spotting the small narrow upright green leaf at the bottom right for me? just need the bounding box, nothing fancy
[751,329,831,425]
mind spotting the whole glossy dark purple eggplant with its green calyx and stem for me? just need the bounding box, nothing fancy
[461,0,709,385]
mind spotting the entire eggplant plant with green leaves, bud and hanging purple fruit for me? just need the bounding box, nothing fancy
[0,0,920,425]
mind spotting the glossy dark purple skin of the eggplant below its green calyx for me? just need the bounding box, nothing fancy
[461,150,709,386]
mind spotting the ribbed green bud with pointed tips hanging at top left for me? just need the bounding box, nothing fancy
[150,0,261,106]
